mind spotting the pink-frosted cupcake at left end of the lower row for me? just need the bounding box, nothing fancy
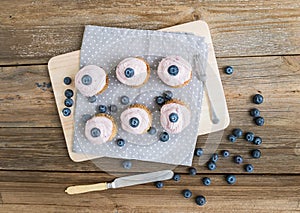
[84,113,117,144]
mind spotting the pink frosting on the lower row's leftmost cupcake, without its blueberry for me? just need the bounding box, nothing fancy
[84,115,115,144]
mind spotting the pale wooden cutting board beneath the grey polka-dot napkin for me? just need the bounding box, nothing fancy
[48,21,229,162]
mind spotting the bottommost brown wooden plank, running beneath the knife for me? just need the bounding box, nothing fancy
[0,171,300,212]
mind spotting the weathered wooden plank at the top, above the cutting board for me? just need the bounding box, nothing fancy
[0,0,300,65]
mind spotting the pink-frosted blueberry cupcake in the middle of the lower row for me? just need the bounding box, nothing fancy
[120,104,152,134]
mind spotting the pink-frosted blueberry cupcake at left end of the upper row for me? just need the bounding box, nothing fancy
[75,65,108,97]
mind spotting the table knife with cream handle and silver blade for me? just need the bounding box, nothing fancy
[65,170,174,195]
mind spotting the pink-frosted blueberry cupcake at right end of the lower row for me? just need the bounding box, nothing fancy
[160,99,191,134]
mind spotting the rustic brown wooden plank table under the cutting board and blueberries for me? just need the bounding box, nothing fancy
[0,0,300,212]
